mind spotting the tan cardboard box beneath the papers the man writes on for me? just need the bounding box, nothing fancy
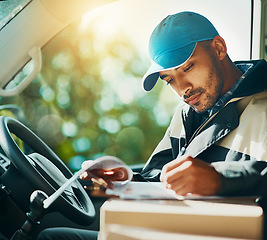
[99,199,263,240]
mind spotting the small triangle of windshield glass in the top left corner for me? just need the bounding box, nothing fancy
[0,0,31,29]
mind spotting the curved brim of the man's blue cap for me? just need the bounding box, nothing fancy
[142,42,196,91]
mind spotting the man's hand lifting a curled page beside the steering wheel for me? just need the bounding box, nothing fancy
[80,160,128,182]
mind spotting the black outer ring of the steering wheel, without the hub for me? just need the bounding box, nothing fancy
[0,116,95,225]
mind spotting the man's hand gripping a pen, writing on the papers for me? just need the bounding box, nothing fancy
[160,156,221,196]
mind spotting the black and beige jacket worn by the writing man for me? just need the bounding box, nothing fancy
[141,60,267,196]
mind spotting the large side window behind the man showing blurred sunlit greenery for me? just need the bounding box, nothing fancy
[0,0,258,170]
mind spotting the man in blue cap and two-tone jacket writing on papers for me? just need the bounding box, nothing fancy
[37,12,267,239]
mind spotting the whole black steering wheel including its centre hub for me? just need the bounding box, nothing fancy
[0,116,95,225]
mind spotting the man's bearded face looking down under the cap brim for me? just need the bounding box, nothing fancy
[160,44,224,112]
